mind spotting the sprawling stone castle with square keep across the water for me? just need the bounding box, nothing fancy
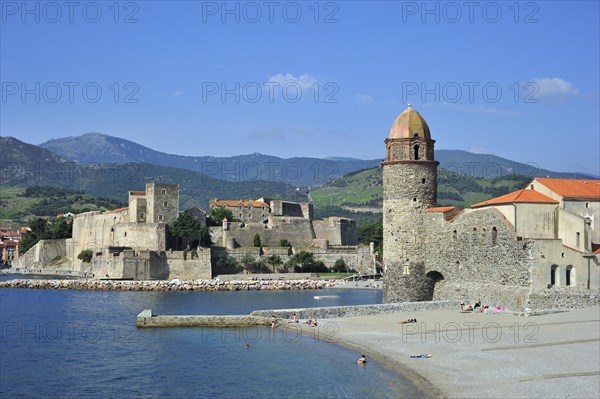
[15,183,375,280]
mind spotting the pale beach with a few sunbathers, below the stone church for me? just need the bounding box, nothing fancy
[290,306,600,398]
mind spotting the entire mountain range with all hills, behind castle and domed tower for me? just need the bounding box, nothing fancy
[0,133,590,216]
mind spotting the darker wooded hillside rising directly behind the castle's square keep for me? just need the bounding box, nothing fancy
[0,138,306,209]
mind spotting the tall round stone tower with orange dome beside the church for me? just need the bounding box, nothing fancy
[382,104,439,302]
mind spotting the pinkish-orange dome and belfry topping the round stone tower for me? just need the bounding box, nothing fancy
[383,104,437,165]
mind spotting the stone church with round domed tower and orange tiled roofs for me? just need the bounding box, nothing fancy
[382,105,600,309]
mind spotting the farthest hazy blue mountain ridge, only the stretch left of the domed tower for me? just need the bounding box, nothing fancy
[40,133,380,186]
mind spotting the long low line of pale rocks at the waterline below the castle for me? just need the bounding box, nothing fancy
[0,279,335,291]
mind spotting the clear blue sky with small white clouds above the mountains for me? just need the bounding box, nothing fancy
[0,1,600,174]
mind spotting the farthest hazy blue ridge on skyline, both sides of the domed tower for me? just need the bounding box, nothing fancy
[40,133,590,186]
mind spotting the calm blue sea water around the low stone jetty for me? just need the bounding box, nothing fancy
[0,280,423,398]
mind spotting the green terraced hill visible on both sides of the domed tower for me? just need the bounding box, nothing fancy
[311,168,531,212]
